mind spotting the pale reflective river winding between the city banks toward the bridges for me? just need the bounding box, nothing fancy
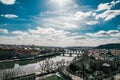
[0,54,76,76]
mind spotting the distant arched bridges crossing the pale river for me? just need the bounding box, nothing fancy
[62,49,88,56]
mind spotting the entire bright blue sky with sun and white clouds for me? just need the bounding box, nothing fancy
[0,0,120,47]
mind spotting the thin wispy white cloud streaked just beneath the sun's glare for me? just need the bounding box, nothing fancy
[34,10,92,30]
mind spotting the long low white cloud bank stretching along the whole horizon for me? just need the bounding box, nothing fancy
[0,27,120,47]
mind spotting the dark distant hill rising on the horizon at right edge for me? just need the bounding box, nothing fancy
[95,43,120,49]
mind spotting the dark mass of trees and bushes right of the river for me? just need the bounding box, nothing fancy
[67,55,120,80]
